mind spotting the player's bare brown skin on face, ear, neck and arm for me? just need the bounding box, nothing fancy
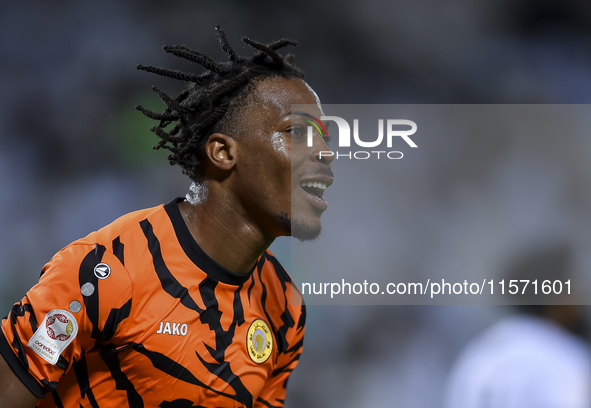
[0,77,332,408]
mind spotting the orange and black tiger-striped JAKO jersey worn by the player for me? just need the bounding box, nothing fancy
[0,199,305,408]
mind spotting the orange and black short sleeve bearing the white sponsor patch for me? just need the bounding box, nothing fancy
[0,243,132,398]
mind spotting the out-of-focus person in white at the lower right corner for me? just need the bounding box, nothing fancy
[445,245,591,408]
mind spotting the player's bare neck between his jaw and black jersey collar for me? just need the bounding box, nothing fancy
[178,184,274,273]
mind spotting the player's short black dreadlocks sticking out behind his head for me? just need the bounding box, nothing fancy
[136,25,304,180]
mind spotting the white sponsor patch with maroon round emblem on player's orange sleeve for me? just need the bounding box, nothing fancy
[27,309,78,365]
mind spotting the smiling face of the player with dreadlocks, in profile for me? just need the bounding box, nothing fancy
[230,77,333,240]
